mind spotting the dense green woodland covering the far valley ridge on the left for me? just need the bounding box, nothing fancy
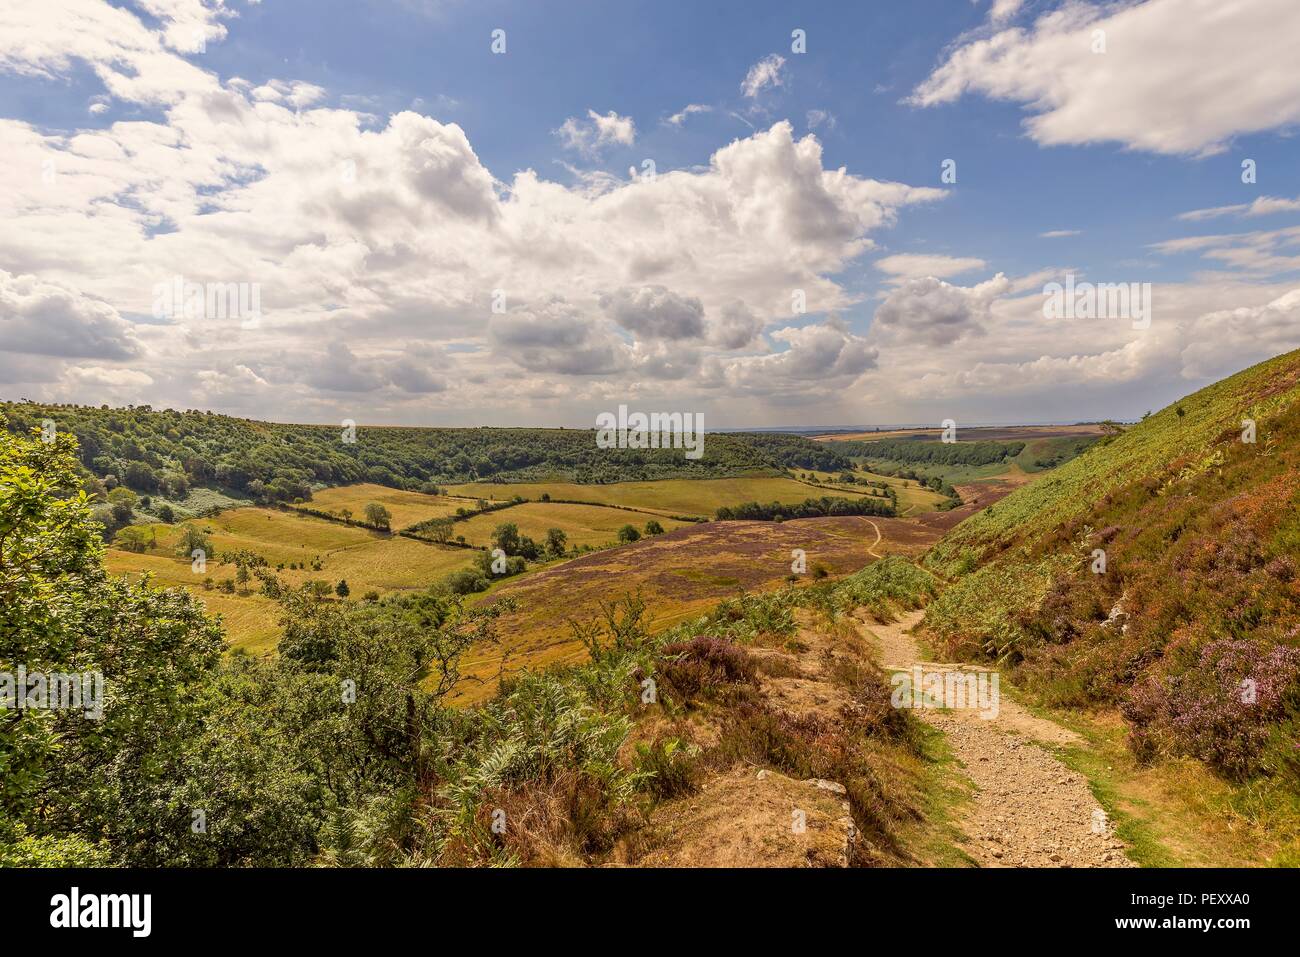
[0,402,852,503]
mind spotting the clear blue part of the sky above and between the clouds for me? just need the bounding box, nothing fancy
[185,0,1300,283]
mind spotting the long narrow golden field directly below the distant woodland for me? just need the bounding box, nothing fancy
[447,477,883,524]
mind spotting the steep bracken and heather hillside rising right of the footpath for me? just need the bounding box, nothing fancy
[926,352,1300,832]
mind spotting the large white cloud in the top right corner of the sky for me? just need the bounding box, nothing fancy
[910,0,1300,155]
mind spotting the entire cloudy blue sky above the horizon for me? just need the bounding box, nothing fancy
[0,0,1300,426]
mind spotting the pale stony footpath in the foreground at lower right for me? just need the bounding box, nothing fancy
[863,611,1134,867]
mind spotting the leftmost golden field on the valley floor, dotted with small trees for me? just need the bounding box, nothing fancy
[105,499,473,654]
